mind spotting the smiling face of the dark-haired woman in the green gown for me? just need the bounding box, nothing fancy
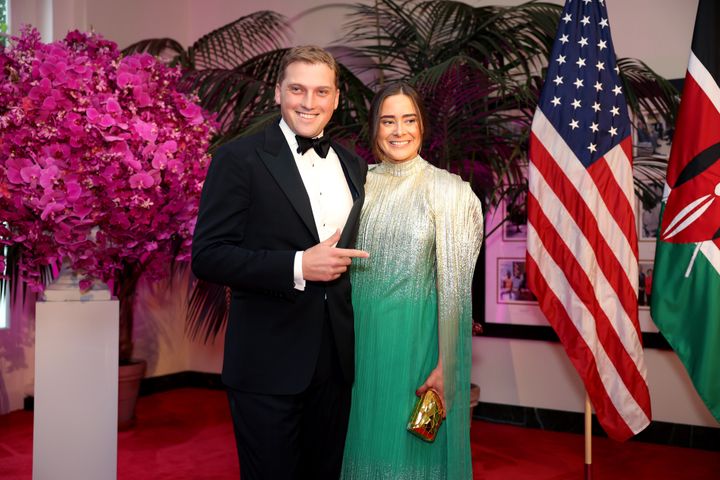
[375,94,422,163]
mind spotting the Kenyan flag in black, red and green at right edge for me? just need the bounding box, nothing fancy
[650,0,720,422]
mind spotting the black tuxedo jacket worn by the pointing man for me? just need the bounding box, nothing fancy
[192,120,367,395]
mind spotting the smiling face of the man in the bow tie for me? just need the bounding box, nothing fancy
[275,62,340,138]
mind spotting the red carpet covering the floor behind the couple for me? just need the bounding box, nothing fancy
[0,389,720,480]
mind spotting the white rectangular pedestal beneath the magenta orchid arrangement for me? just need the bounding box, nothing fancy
[33,294,119,480]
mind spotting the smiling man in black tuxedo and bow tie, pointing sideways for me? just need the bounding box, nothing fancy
[192,47,368,480]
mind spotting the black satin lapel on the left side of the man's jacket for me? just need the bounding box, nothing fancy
[258,124,320,242]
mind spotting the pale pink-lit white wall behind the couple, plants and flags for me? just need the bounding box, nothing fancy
[0,0,717,426]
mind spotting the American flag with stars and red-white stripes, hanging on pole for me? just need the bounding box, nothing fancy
[527,0,651,440]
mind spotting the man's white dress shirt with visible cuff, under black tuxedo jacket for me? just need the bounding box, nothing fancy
[280,120,353,290]
